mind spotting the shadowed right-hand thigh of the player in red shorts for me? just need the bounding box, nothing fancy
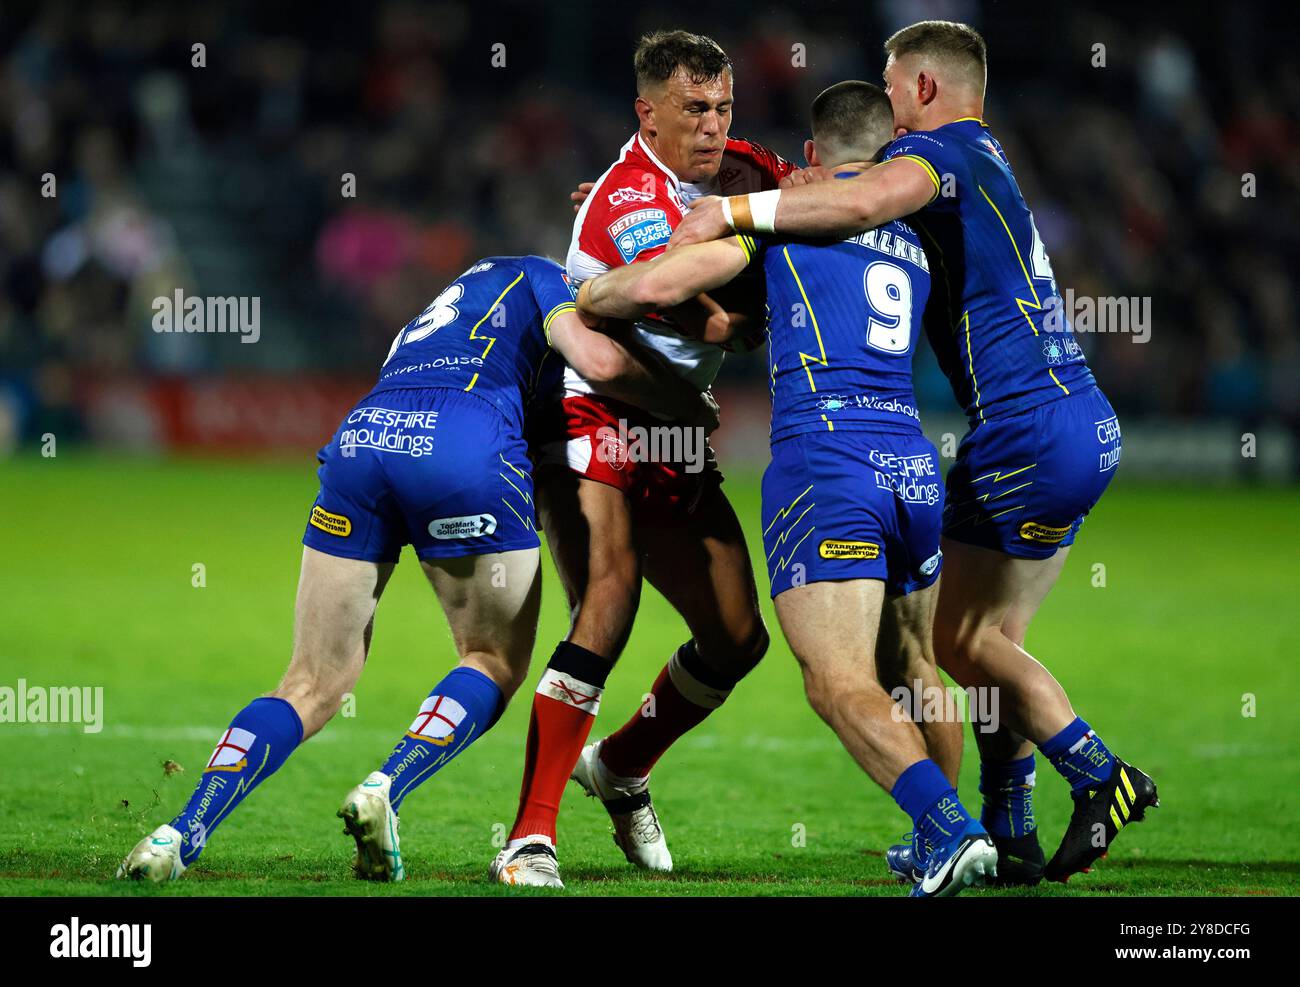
[641,482,767,659]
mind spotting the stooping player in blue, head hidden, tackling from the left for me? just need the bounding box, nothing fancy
[117,257,716,882]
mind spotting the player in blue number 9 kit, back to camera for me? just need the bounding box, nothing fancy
[579,82,997,897]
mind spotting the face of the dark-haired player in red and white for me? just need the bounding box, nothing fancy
[641,69,732,182]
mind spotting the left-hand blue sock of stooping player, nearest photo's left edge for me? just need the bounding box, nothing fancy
[172,697,303,867]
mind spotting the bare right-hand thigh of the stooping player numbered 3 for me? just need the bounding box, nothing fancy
[420,549,542,675]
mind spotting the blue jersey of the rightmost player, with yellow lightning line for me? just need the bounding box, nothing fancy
[883,117,1095,423]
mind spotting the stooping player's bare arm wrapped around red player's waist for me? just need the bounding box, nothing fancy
[550,312,718,432]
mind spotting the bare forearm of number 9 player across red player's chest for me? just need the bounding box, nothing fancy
[577,237,750,320]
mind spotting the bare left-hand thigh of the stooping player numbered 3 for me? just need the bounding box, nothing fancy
[293,546,393,675]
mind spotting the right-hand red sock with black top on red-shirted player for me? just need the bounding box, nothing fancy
[601,641,732,778]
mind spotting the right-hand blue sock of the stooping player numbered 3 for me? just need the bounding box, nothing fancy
[380,666,506,811]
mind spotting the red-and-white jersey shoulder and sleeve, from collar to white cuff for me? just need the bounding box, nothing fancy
[566,135,685,280]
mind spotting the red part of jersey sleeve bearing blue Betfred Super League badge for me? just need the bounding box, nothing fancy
[577,166,681,268]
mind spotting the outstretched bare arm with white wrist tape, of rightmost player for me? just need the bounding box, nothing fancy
[668,159,937,252]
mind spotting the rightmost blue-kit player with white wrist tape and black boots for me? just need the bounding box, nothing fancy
[672,21,1158,883]
